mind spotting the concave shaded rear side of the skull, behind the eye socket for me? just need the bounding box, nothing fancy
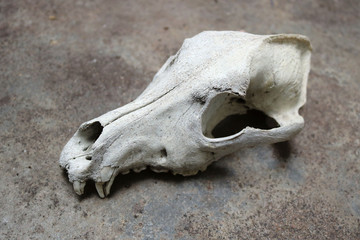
[246,35,311,124]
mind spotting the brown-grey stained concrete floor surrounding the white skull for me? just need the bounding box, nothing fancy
[0,0,360,239]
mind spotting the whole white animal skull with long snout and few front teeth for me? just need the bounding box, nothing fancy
[60,31,311,198]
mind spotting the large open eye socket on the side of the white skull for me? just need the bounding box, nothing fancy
[202,93,279,138]
